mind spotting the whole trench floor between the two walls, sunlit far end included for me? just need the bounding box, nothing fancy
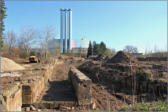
[34,64,77,109]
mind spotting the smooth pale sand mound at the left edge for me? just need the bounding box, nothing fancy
[1,57,24,72]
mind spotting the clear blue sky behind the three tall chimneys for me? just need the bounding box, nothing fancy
[5,1,167,52]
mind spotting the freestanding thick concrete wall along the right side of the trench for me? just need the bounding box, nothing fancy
[69,68,92,105]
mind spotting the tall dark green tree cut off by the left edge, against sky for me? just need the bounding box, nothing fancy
[0,0,6,50]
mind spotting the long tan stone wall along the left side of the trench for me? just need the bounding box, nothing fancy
[0,65,53,111]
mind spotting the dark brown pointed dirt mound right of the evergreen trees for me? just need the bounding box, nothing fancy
[107,51,137,63]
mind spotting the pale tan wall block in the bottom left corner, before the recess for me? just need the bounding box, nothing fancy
[1,84,22,111]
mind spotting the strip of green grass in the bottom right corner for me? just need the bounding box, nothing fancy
[121,102,168,111]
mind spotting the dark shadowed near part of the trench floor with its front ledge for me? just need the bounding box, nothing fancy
[34,80,77,109]
